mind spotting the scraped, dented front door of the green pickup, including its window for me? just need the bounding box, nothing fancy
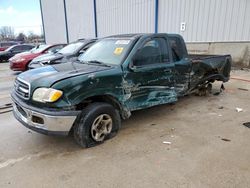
[124,36,177,111]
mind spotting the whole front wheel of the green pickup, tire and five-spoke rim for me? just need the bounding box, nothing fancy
[74,102,121,147]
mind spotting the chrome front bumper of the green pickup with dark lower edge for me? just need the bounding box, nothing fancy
[13,94,79,136]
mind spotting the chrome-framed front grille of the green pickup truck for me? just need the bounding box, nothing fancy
[14,78,30,99]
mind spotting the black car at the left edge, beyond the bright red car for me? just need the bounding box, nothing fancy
[0,44,34,62]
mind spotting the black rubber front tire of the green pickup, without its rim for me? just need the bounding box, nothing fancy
[73,102,121,148]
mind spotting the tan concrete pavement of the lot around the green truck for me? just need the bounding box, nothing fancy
[0,64,250,188]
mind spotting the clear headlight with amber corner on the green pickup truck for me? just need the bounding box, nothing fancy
[32,88,63,102]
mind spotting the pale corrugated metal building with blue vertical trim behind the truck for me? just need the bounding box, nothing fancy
[40,0,250,66]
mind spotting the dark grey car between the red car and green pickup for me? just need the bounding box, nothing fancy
[29,39,96,69]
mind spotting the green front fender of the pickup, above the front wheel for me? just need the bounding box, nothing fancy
[53,68,123,107]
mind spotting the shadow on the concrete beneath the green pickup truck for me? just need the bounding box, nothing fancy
[27,92,222,157]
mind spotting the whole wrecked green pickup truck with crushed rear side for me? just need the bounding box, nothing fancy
[11,34,232,147]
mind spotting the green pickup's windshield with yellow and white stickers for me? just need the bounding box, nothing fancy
[79,39,131,65]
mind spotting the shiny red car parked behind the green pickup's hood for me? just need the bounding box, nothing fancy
[9,44,65,71]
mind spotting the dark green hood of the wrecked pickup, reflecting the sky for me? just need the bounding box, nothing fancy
[18,62,112,88]
